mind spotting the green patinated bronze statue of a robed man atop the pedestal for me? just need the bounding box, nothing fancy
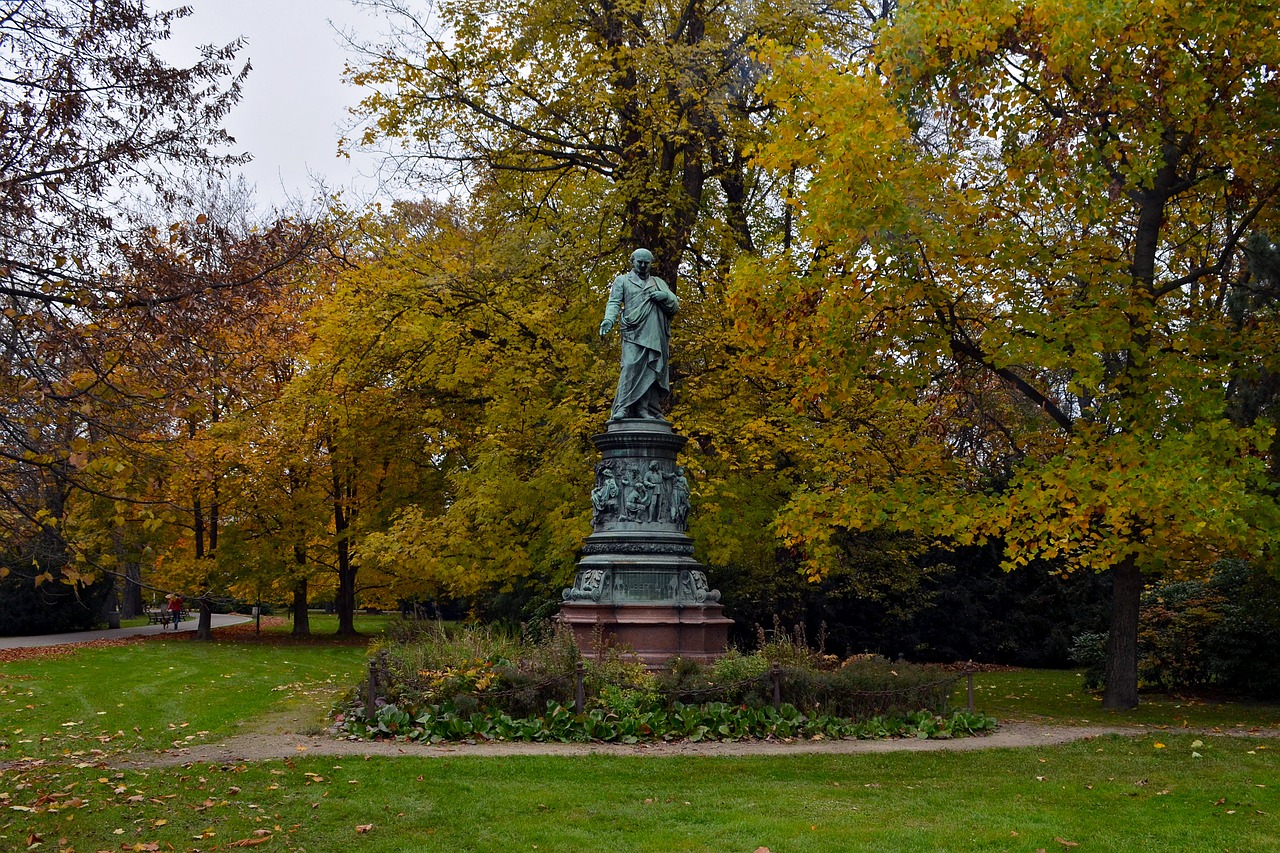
[600,248,680,420]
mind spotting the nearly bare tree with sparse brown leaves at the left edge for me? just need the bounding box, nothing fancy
[0,0,247,591]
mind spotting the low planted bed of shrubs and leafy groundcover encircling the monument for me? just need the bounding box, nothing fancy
[334,622,996,743]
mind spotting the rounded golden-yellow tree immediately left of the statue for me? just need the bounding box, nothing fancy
[305,202,591,617]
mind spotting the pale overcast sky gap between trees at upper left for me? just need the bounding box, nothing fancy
[156,0,396,206]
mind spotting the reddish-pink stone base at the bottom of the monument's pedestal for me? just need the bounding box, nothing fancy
[559,602,733,667]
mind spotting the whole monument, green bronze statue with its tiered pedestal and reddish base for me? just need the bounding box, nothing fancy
[559,248,733,666]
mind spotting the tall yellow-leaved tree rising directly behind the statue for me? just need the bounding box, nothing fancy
[335,0,921,617]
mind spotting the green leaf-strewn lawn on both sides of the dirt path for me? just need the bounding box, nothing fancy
[0,635,1280,853]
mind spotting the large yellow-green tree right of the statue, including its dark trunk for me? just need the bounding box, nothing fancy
[736,0,1280,708]
